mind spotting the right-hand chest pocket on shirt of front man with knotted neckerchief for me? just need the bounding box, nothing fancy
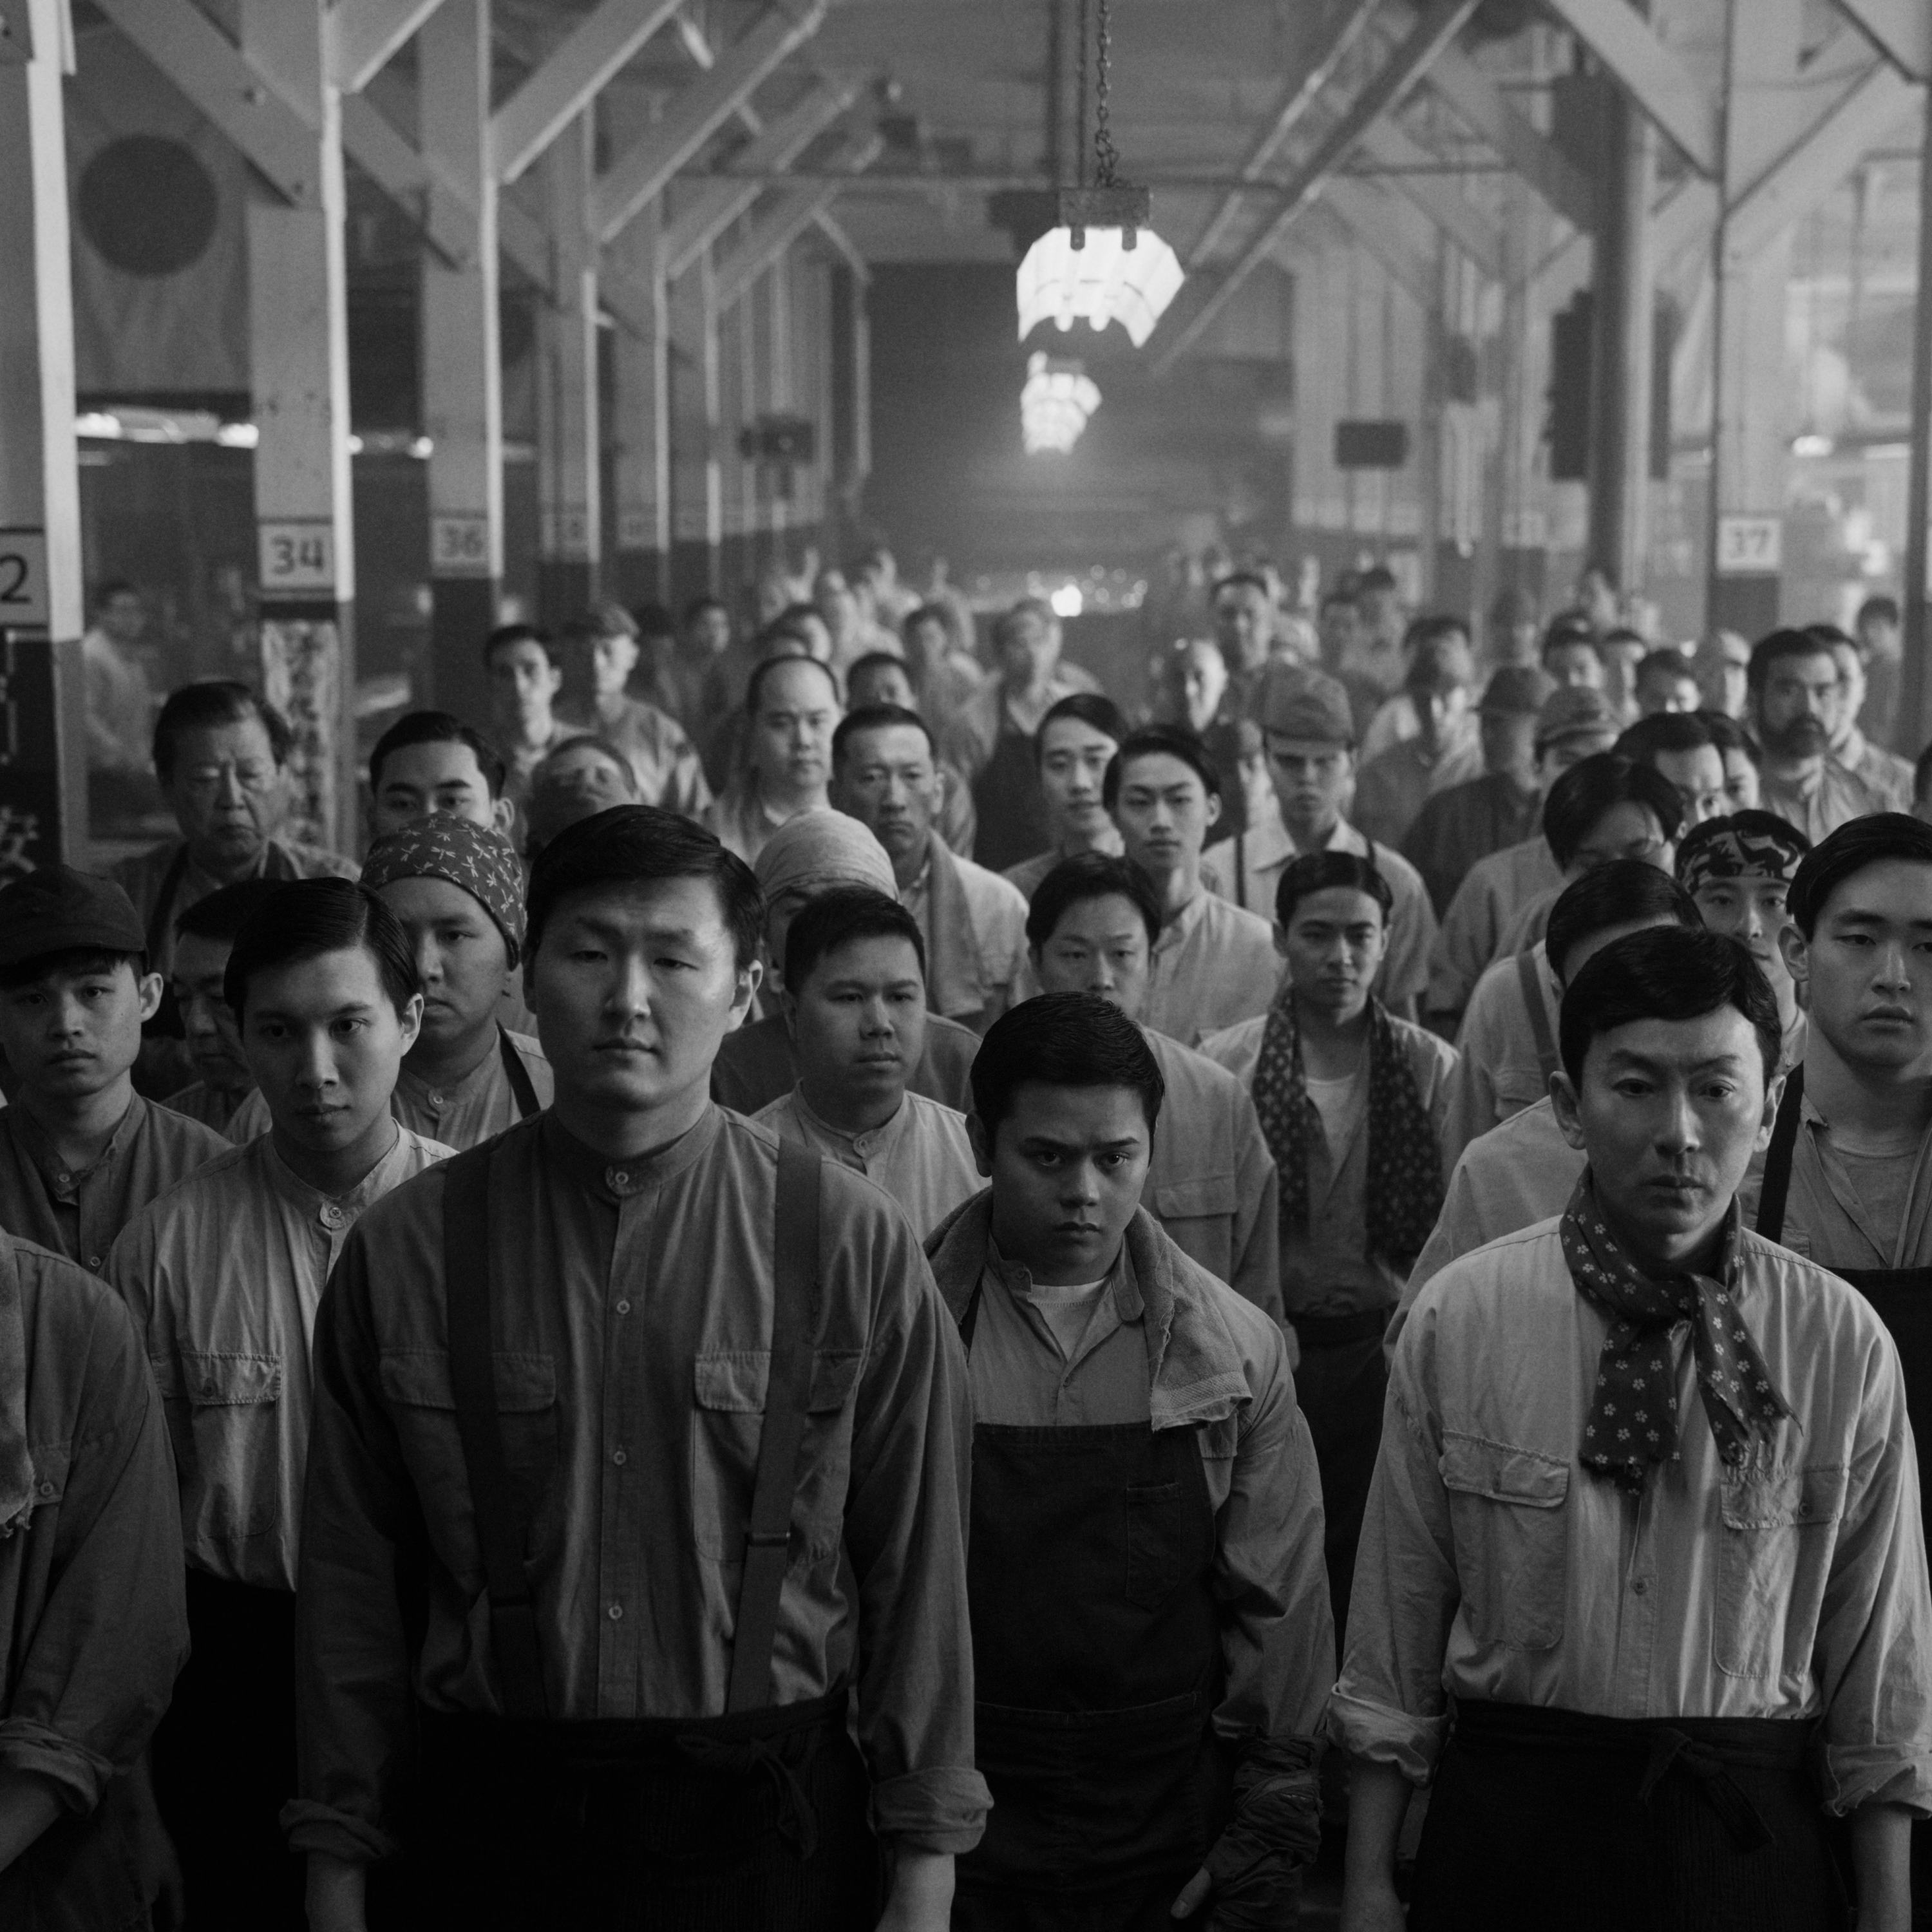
[1712,1466,1847,1677]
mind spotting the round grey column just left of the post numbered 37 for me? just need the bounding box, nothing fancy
[1590,89,1654,589]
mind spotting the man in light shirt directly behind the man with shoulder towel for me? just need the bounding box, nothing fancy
[1026,852,1281,1321]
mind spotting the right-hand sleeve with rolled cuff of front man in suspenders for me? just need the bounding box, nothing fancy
[844,1219,993,1853]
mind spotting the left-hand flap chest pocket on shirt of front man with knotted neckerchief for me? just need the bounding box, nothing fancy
[1439,1435,1571,1650]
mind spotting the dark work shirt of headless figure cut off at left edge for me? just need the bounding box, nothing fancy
[0,1235,187,1812]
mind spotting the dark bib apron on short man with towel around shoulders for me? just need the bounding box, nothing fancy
[954,1289,1233,1901]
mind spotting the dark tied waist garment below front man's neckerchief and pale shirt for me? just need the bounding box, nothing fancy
[1408,1704,1851,1932]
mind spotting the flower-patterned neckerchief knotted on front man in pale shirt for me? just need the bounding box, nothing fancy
[1561,1169,1791,1495]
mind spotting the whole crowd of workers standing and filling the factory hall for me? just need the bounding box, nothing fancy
[11,554,1932,1932]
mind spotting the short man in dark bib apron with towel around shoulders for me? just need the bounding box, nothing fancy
[927,993,1333,1932]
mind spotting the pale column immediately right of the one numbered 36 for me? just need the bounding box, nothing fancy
[537,108,603,624]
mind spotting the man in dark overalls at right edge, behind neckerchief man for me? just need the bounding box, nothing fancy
[1756,811,1932,1911]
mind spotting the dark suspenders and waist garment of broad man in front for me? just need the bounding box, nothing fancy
[392,1144,877,1932]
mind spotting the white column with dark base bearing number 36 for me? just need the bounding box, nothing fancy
[415,0,502,719]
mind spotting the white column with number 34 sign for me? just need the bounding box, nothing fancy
[240,0,357,850]
